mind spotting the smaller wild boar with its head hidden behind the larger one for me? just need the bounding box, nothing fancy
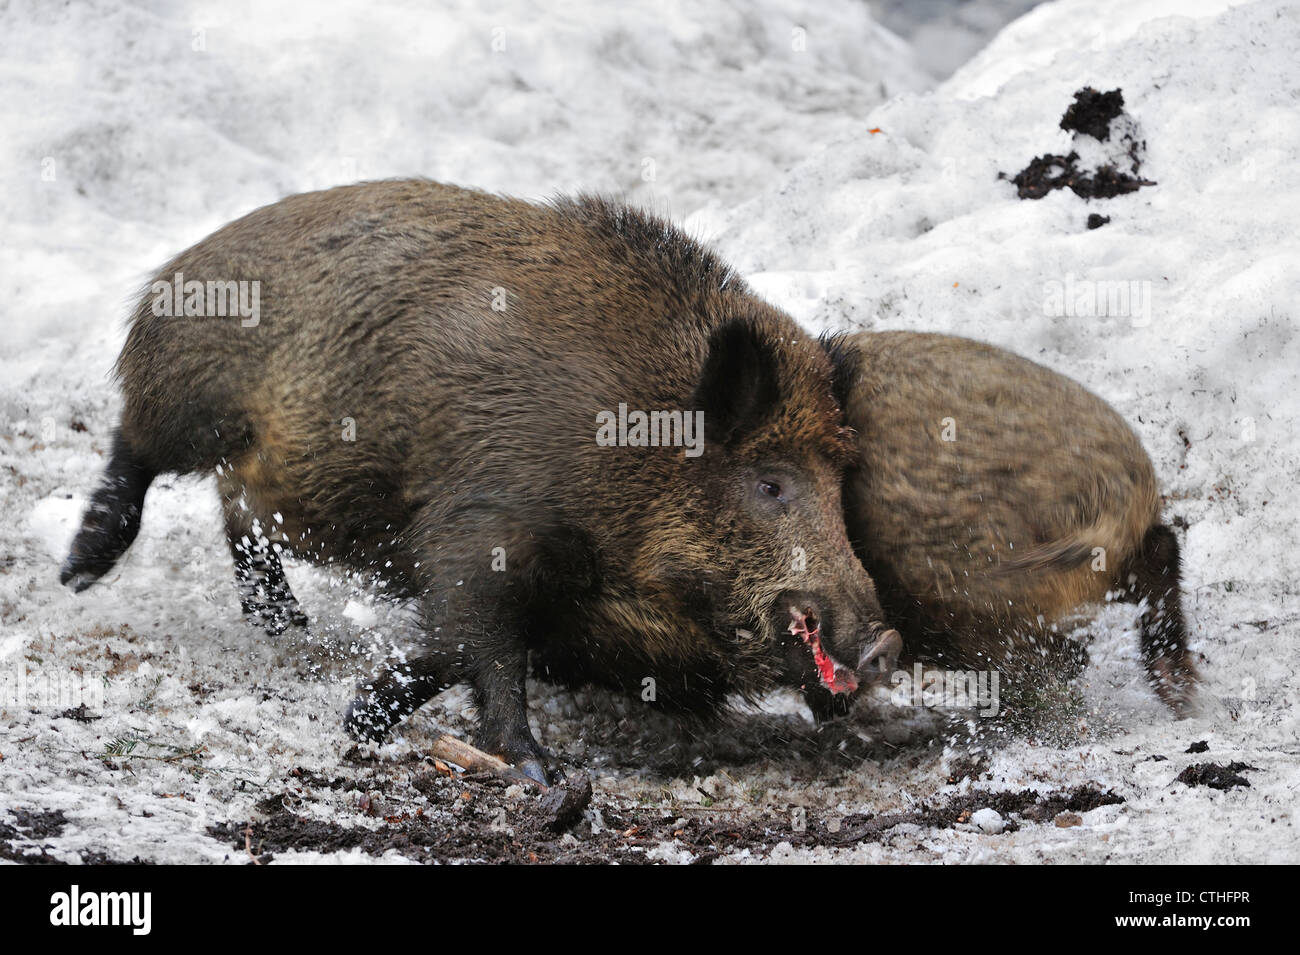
[837,331,1196,712]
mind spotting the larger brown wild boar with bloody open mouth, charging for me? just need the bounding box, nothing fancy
[62,181,898,778]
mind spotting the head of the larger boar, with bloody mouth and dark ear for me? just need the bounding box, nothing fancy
[684,314,901,694]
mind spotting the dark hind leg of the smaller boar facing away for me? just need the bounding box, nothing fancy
[1121,524,1196,716]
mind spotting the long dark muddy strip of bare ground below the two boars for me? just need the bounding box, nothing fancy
[207,767,1125,864]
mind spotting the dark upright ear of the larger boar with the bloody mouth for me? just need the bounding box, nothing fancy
[693,318,781,446]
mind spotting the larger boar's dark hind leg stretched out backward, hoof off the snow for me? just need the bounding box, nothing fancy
[59,431,157,592]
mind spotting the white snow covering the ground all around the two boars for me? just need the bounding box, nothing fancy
[0,0,1300,863]
